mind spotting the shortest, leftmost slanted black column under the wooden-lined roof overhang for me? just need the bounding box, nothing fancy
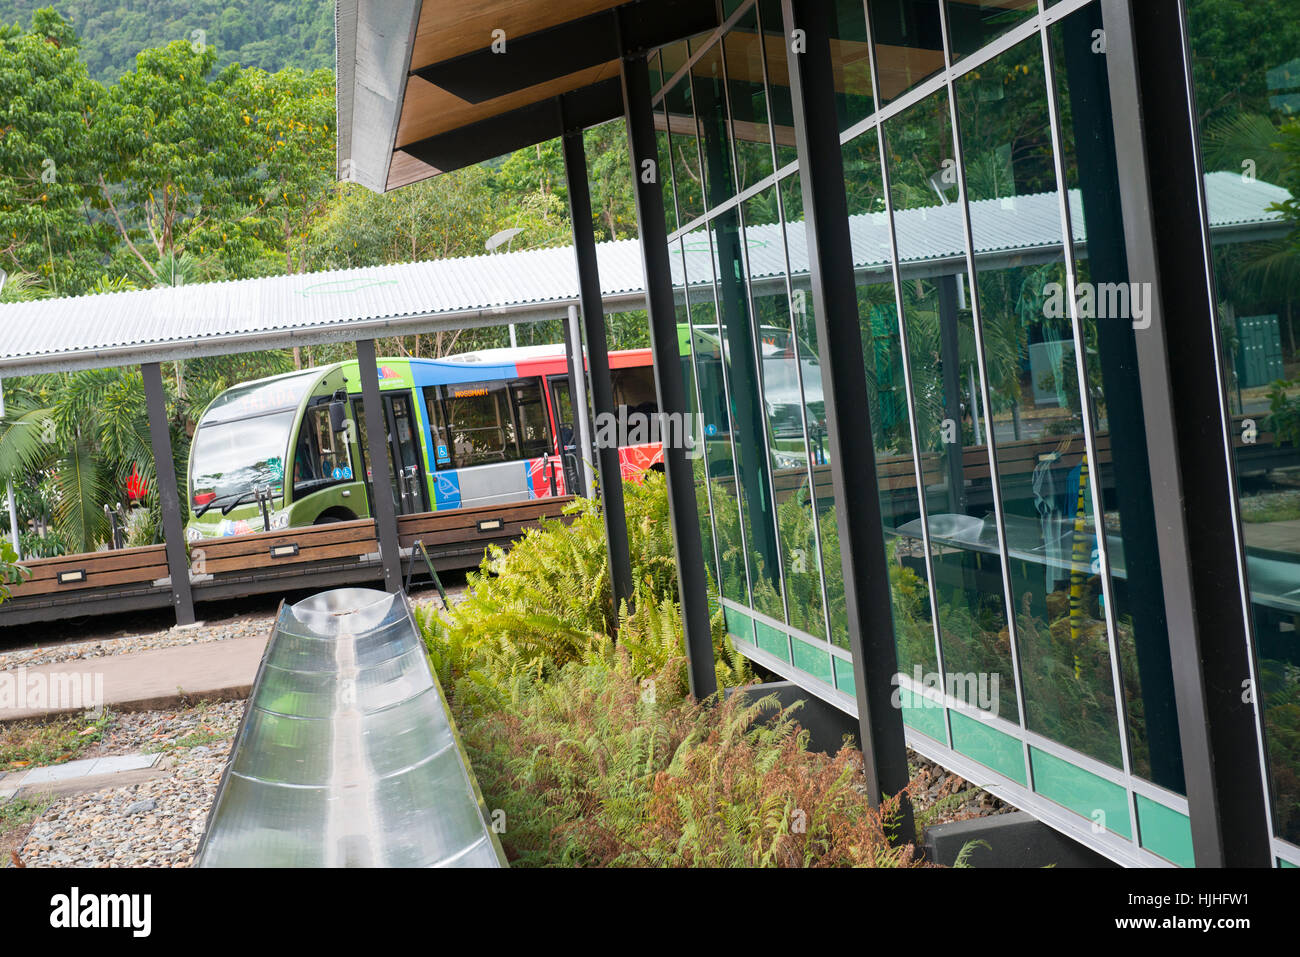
[562,123,632,623]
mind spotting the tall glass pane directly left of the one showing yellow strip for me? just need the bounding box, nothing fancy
[884,91,1018,722]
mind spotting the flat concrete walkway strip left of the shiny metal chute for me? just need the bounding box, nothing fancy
[0,637,267,723]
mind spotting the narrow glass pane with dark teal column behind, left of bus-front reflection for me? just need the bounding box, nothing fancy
[711,208,785,620]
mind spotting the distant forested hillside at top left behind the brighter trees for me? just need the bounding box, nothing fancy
[0,0,334,83]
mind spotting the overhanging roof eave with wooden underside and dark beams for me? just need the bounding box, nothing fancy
[335,0,722,192]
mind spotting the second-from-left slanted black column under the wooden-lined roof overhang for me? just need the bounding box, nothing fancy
[616,44,718,698]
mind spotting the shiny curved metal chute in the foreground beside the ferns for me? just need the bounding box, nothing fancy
[195,588,506,867]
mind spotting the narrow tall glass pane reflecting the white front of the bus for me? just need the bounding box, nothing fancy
[744,187,827,638]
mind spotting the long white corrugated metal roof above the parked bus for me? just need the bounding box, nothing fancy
[0,243,644,378]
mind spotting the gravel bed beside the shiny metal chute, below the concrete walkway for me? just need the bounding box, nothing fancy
[18,701,244,867]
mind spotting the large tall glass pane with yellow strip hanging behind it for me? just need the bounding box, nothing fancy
[956,36,1123,767]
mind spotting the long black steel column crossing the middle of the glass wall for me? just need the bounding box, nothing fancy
[781,0,914,841]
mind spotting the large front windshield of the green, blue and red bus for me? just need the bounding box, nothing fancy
[190,410,296,507]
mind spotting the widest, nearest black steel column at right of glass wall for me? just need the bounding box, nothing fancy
[1089,0,1271,867]
